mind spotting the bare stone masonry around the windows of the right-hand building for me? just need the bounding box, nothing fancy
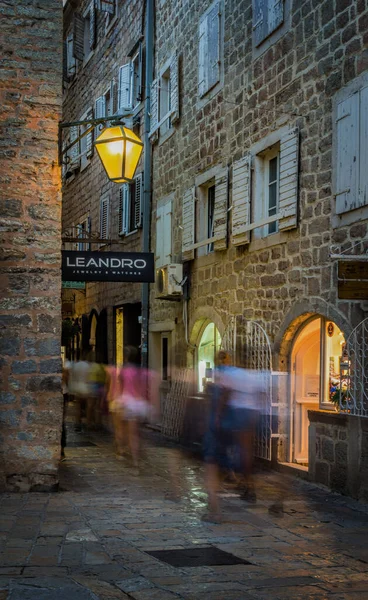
[151,0,368,360]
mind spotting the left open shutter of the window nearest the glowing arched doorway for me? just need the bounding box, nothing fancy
[231,153,251,246]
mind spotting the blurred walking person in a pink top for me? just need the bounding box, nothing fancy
[117,346,158,469]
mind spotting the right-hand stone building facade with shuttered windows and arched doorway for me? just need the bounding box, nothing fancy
[150,0,368,492]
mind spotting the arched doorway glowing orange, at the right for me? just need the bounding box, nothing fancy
[289,315,345,466]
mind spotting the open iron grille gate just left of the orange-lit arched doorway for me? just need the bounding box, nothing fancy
[221,315,272,460]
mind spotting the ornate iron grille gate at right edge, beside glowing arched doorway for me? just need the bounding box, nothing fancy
[340,317,368,417]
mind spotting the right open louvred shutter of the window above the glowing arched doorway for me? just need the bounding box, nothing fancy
[279,128,299,231]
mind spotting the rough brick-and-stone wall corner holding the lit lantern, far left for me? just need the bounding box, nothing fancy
[0,0,63,491]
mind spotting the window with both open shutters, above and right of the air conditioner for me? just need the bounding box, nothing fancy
[182,167,228,260]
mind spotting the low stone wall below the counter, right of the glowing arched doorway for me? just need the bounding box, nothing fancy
[308,411,368,501]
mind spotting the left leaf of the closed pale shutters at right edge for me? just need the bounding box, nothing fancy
[335,93,358,215]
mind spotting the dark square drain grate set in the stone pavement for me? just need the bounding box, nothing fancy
[146,546,252,567]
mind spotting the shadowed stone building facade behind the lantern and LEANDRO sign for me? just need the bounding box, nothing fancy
[63,0,145,362]
